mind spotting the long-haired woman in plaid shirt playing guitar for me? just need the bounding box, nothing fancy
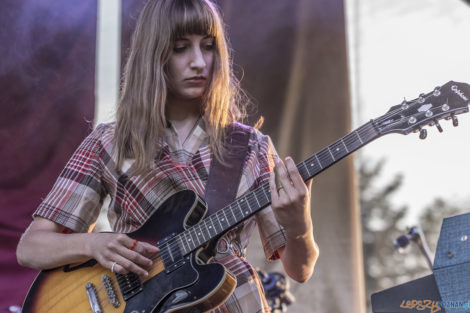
[17,0,318,312]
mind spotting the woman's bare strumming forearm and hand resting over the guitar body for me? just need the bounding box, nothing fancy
[16,217,158,276]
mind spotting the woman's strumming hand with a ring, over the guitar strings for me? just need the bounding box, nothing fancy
[87,233,159,277]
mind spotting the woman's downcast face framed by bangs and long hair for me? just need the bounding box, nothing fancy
[167,35,215,100]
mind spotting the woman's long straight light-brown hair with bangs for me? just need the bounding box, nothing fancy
[115,0,246,174]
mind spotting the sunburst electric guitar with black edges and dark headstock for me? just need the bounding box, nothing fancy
[23,81,470,313]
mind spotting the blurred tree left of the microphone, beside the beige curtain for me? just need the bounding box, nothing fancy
[358,159,432,311]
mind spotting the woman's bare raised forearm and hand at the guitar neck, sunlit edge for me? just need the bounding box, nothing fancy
[270,157,319,282]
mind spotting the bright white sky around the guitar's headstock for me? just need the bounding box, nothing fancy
[346,0,470,225]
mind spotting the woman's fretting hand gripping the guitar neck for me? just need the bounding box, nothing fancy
[269,157,312,237]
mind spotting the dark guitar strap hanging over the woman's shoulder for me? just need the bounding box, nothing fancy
[204,123,251,215]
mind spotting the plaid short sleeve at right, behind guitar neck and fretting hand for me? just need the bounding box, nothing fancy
[255,132,286,261]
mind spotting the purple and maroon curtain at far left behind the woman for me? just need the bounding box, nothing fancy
[0,0,97,311]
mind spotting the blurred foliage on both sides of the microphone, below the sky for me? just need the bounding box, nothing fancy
[358,159,467,312]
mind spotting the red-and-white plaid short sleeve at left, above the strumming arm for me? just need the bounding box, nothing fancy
[33,124,107,232]
